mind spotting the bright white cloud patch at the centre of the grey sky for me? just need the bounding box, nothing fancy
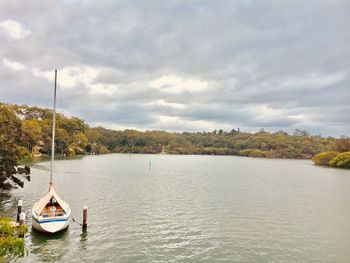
[150,75,208,94]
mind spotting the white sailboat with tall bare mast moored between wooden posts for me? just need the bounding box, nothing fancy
[32,70,71,233]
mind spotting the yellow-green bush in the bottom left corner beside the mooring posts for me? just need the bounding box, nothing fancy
[0,218,28,259]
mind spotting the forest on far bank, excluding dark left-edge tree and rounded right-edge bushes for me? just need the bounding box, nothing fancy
[0,103,348,159]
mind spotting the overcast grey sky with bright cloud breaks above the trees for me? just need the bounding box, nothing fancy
[0,0,350,137]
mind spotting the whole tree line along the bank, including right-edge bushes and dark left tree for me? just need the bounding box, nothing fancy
[0,103,350,189]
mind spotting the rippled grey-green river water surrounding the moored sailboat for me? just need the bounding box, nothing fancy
[1,154,350,262]
